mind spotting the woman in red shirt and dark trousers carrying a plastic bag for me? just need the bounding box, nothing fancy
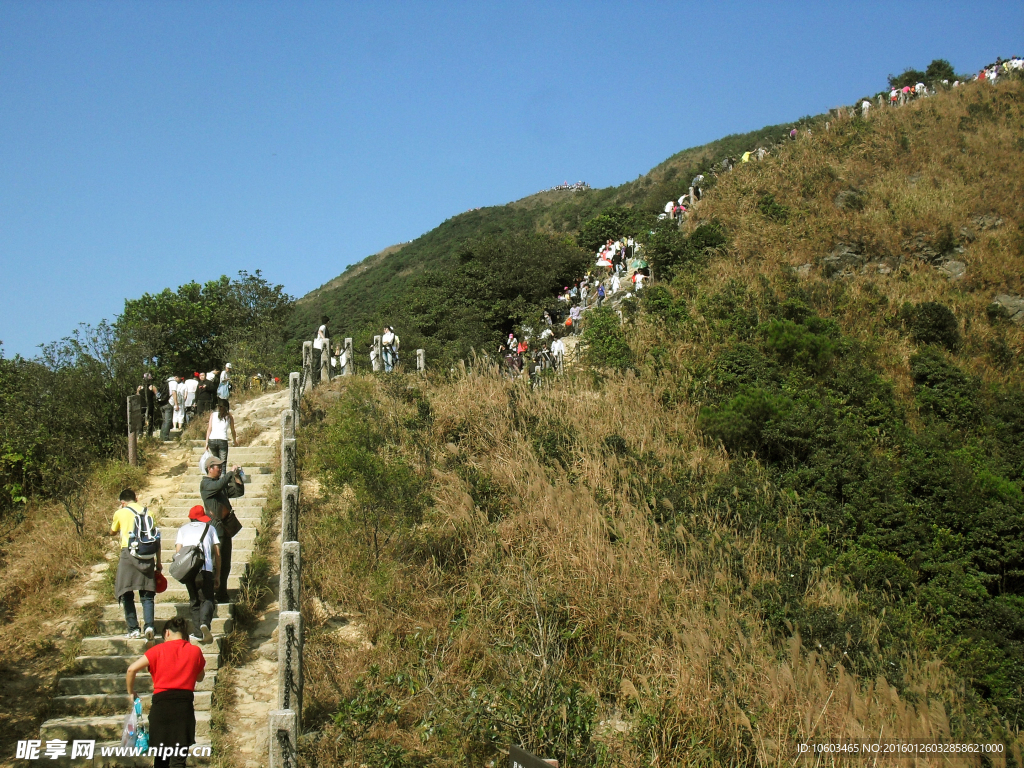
[125,616,206,768]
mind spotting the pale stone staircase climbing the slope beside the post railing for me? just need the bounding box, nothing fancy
[40,440,279,766]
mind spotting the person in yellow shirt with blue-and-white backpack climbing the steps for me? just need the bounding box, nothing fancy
[111,488,163,640]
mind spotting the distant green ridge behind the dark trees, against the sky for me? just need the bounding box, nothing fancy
[288,119,790,360]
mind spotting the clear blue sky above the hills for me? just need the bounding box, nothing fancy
[0,0,1024,356]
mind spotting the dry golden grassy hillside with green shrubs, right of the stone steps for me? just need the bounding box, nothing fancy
[300,82,1024,766]
